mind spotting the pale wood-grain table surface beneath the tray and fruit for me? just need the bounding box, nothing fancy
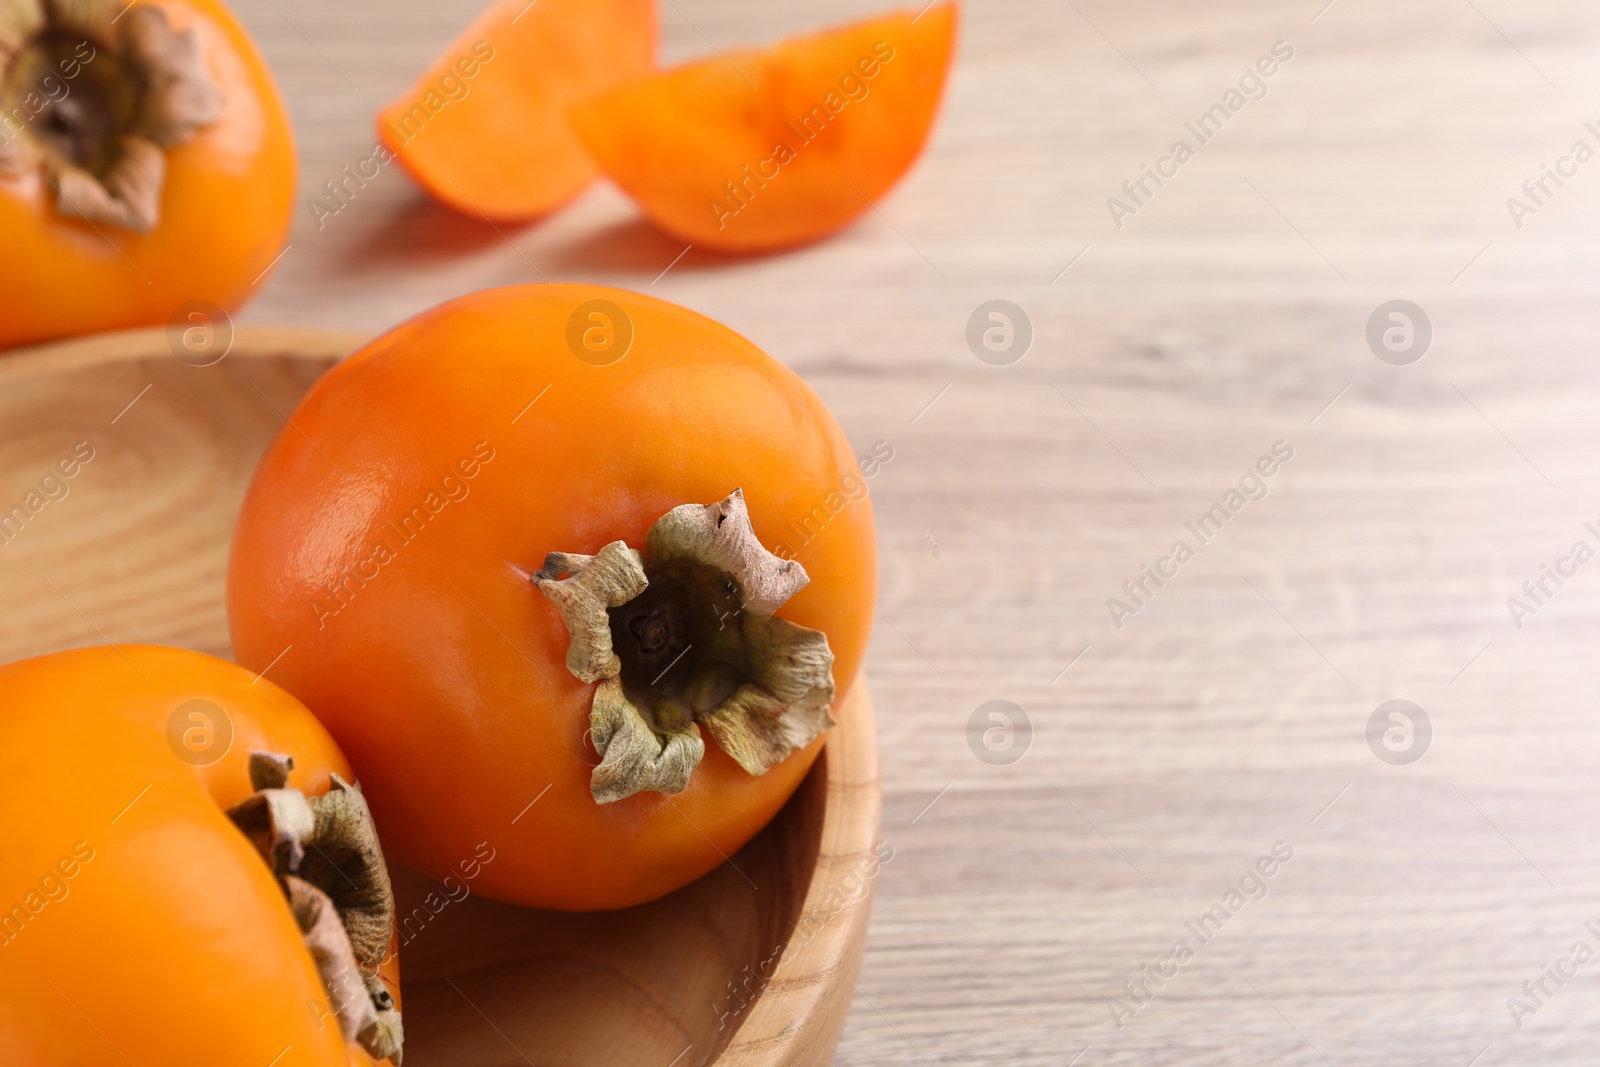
[237,0,1600,1067]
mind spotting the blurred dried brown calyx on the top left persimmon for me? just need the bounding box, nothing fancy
[0,0,222,234]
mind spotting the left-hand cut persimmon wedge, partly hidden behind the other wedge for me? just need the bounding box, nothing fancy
[378,0,656,221]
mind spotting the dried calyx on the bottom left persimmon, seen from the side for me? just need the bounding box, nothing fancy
[227,752,403,1064]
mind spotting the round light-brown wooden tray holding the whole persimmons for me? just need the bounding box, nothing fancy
[0,326,880,1067]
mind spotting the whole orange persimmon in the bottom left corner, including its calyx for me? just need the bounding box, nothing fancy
[0,645,402,1067]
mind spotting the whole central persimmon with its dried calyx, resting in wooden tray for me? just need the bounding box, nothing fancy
[227,285,877,910]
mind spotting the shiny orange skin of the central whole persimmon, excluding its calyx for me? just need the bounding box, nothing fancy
[227,285,877,910]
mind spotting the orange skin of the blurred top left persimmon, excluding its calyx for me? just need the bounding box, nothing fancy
[0,0,294,349]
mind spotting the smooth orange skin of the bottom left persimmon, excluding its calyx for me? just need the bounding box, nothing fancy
[0,645,398,1067]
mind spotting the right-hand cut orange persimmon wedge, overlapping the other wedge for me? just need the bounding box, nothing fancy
[571,3,957,251]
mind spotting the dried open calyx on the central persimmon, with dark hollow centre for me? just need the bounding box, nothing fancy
[534,490,834,803]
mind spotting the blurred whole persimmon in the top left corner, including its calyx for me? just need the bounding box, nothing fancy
[0,0,294,349]
